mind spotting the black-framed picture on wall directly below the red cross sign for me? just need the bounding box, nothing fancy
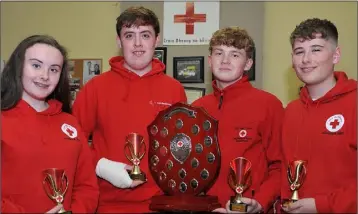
[173,56,204,83]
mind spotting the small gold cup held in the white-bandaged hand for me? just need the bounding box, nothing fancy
[124,133,147,181]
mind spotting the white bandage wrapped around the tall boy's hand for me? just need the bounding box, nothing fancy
[96,158,133,189]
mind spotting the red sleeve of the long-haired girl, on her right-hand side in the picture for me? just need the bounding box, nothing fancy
[71,131,99,213]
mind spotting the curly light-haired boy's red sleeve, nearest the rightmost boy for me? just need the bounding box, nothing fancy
[254,99,284,212]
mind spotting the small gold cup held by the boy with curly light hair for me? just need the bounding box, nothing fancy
[228,157,252,212]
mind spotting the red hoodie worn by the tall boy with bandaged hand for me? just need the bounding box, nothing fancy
[73,57,186,212]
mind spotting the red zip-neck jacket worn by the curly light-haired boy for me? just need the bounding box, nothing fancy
[193,76,283,211]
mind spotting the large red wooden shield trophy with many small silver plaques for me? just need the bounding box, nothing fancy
[148,103,221,211]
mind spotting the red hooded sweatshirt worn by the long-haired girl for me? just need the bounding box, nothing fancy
[1,100,99,213]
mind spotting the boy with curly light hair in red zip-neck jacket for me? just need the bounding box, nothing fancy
[193,27,283,213]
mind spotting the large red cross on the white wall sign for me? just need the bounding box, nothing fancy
[174,2,206,34]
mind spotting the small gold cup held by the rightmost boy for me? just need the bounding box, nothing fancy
[282,160,307,206]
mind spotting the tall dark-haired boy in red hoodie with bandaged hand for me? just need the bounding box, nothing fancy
[73,7,186,213]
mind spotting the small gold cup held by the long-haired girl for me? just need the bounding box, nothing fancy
[42,168,72,214]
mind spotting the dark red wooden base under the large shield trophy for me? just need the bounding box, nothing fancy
[149,195,221,212]
